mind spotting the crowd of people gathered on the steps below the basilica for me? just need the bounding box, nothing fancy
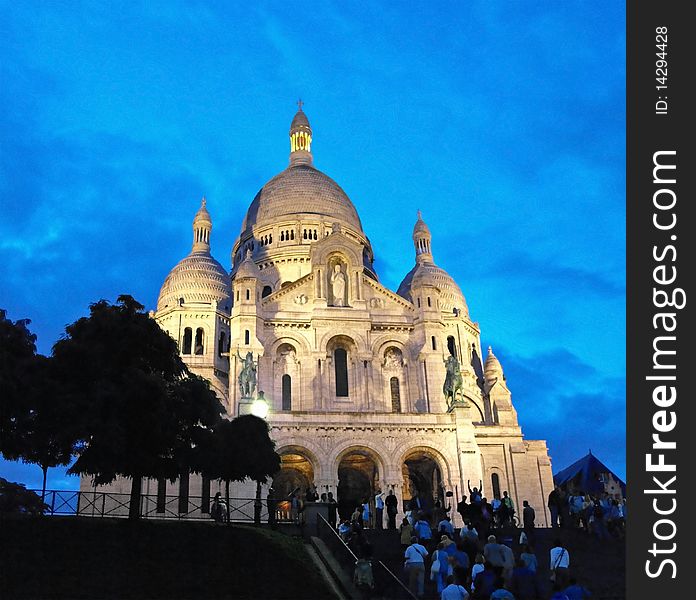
[338,485,625,600]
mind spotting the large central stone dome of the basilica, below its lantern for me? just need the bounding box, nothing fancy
[242,164,362,232]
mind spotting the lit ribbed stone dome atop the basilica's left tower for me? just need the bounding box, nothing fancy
[157,252,232,311]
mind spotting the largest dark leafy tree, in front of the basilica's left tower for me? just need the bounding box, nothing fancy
[53,296,221,519]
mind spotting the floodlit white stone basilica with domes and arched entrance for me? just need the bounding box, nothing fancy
[88,107,553,526]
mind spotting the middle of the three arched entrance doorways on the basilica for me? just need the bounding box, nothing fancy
[336,449,379,519]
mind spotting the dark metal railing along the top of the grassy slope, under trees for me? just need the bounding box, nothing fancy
[31,490,290,523]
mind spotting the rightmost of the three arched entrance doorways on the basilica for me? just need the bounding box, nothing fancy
[402,450,444,514]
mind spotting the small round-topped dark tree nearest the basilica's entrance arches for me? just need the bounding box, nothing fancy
[202,415,280,518]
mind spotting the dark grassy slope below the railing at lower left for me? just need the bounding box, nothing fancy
[0,517,333,600]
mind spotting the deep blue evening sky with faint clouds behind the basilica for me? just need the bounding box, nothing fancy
[0,0,625,488]
